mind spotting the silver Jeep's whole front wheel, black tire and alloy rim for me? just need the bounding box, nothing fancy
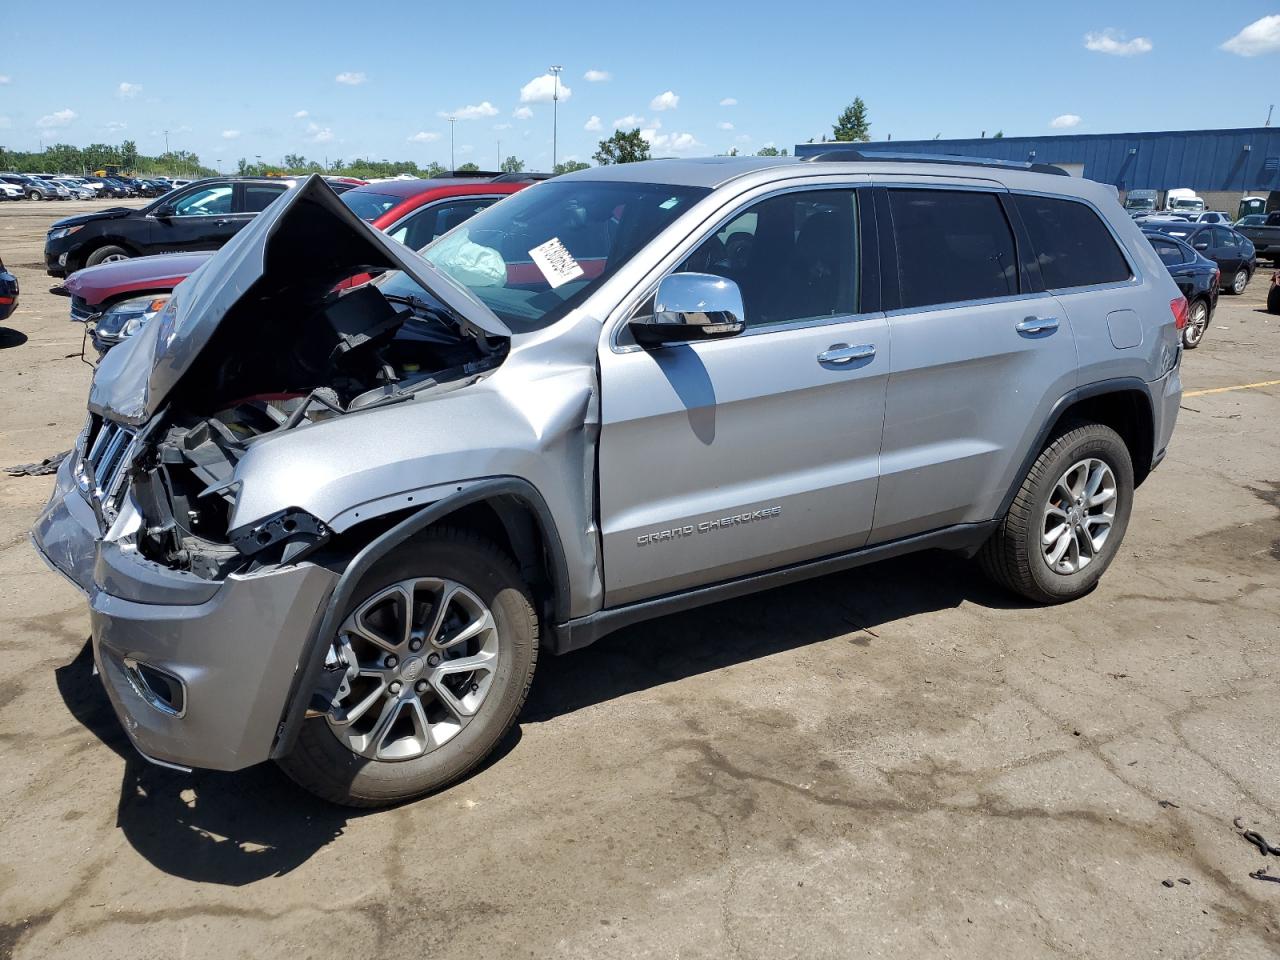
[279,527,538,806]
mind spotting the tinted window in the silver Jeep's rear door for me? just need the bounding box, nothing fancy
[888,189,1018,307]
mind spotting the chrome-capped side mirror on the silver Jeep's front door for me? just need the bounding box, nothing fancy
[627,274,746,347]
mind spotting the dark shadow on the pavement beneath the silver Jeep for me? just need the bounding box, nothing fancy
[56,553,1020,886]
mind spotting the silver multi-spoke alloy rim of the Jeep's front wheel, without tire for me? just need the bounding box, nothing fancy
[325,577,499,760]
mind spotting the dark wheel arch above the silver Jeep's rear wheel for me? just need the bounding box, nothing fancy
[997,376,1156,517]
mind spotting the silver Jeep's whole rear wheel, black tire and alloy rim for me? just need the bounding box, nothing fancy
[978,424,1134,603]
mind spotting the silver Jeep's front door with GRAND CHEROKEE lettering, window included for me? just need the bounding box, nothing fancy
[599,188,890,605]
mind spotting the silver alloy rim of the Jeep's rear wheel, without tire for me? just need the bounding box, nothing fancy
[1041,457,1119,576]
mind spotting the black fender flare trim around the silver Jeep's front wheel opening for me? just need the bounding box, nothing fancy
[271,476,570,759]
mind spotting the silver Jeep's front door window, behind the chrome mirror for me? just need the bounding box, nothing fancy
[678,189,859,326]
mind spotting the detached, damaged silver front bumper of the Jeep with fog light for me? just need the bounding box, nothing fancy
[32,457,337,771]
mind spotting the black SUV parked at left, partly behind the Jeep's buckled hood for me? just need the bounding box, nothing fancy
[45,177,351,276]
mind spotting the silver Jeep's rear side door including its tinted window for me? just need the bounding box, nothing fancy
[870,178,1076,543]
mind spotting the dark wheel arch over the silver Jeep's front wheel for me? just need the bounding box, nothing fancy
[271,477,571,758]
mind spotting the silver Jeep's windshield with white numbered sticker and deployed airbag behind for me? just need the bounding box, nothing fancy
[394,180,709,333]
